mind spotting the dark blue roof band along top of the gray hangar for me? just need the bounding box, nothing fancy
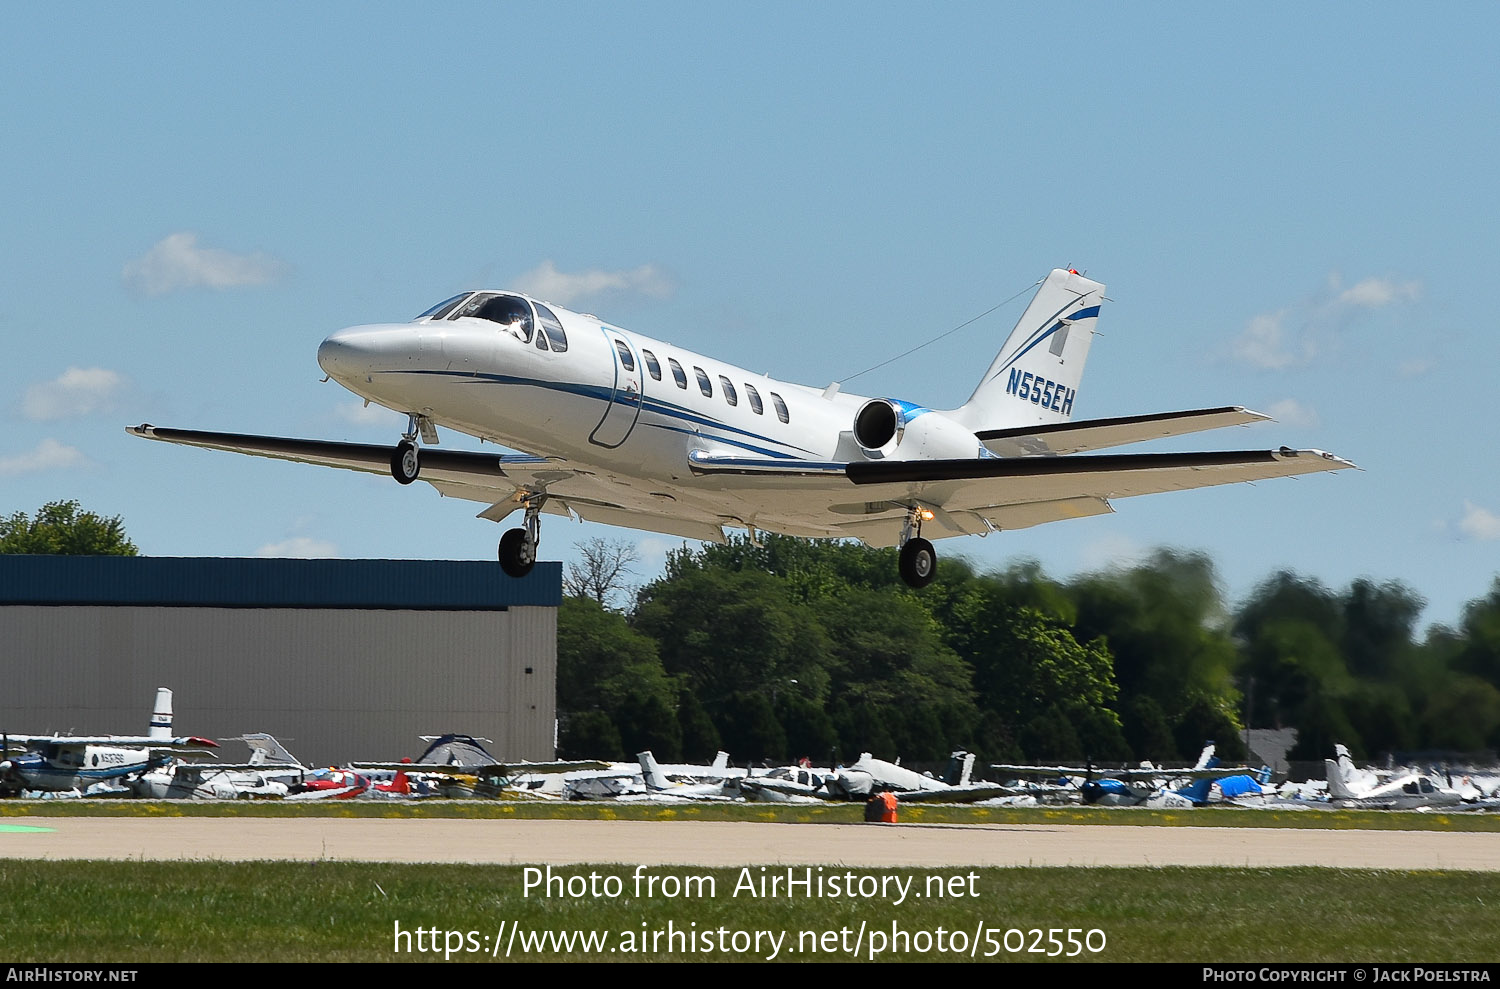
[0,555,563,611]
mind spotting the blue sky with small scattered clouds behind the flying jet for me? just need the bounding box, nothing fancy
[0,3,1500,624]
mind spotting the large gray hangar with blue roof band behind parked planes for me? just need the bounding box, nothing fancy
[0,555,563,765]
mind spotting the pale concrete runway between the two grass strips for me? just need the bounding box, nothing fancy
[0,818,1500,872]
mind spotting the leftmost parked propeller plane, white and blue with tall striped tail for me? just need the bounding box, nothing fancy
[0,687,218,792]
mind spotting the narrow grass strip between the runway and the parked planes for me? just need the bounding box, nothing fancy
[0,800,1500,831]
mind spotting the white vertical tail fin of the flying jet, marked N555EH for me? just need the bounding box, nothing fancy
[950,269,1104,432]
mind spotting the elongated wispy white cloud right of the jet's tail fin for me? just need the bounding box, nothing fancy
[1230,273,1422,371]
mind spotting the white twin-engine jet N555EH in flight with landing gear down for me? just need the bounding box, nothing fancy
[129,269,1353,587]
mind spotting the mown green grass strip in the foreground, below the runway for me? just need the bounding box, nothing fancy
[0,860,1500,963]
